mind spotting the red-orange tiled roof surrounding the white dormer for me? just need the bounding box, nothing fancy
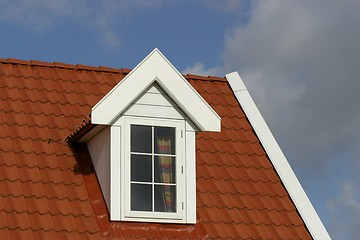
[0,59,311,240]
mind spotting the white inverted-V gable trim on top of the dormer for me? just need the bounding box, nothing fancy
[91,49,221,132]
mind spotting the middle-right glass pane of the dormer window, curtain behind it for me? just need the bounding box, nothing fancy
[154,156,176,183]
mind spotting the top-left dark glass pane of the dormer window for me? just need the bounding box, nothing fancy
[130,125,152,153]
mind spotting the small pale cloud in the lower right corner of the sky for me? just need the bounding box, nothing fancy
[328,181,360,240]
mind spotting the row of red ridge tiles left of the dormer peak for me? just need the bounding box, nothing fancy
[0,58,131,74]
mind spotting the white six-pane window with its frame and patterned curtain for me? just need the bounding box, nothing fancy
[124,117,185,219]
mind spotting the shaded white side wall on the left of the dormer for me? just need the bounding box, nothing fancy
[87,127,110,210]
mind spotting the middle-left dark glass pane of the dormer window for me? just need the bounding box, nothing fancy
[131,154,152,182]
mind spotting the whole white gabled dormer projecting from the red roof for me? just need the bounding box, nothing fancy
[82,49,221,223]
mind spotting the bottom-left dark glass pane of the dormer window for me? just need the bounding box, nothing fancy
[131,183,152,212]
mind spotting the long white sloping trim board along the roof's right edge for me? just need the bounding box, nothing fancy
[226,72,331,240]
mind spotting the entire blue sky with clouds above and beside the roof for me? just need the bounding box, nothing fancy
[0,0,360,240]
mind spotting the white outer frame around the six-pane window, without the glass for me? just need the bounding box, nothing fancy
[121,116,186,223]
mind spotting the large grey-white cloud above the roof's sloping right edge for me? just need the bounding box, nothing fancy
[223,0,360,174]
